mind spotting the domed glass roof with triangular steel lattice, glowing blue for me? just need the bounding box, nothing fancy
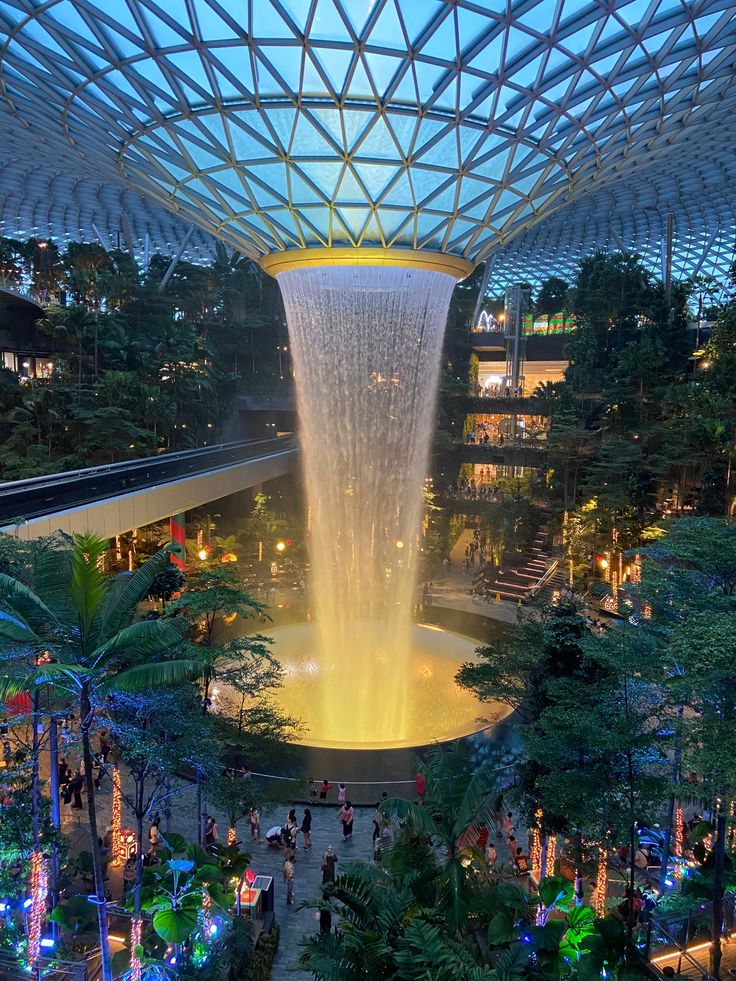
[0,0,736,281]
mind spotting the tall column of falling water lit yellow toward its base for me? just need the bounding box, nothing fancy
[264,253,468,742]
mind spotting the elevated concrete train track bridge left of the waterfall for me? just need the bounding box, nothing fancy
[0,437,298,540]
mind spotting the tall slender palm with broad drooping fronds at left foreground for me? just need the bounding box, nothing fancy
[0,534,201,981]
